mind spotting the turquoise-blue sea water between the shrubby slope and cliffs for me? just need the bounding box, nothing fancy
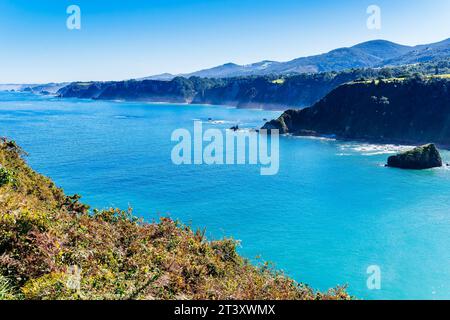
[0,93,450,299]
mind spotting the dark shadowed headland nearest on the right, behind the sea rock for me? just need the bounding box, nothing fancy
[264,78,450,144]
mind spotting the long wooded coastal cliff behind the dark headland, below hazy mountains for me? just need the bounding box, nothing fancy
[58,59,450,110]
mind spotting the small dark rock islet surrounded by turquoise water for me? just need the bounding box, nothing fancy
[387,144,442,170]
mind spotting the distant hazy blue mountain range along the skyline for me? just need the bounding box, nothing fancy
[145,38,450,80]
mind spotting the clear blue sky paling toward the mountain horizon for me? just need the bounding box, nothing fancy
[0,0,450,83]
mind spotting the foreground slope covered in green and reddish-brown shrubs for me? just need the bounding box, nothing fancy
[0,139,349,299]
